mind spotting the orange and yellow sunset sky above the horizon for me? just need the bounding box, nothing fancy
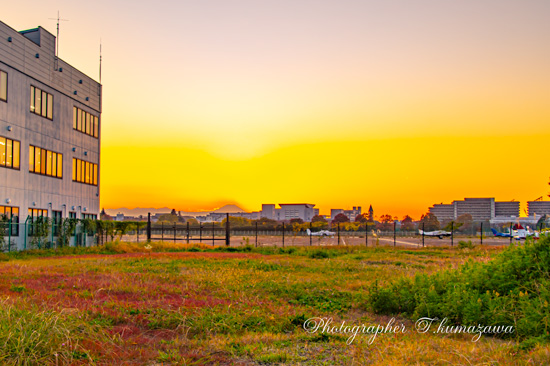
[0,0,550,219]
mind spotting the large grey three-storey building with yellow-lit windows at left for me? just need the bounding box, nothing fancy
[0,22,102,248]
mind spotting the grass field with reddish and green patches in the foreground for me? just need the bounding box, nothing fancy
[0,243,550,365]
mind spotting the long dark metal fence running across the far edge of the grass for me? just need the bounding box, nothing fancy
[0,214,544,252]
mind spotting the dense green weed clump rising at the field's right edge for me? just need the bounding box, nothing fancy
[368,236,550,341]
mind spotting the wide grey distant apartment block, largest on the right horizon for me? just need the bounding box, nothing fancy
[429,198,519,221]
